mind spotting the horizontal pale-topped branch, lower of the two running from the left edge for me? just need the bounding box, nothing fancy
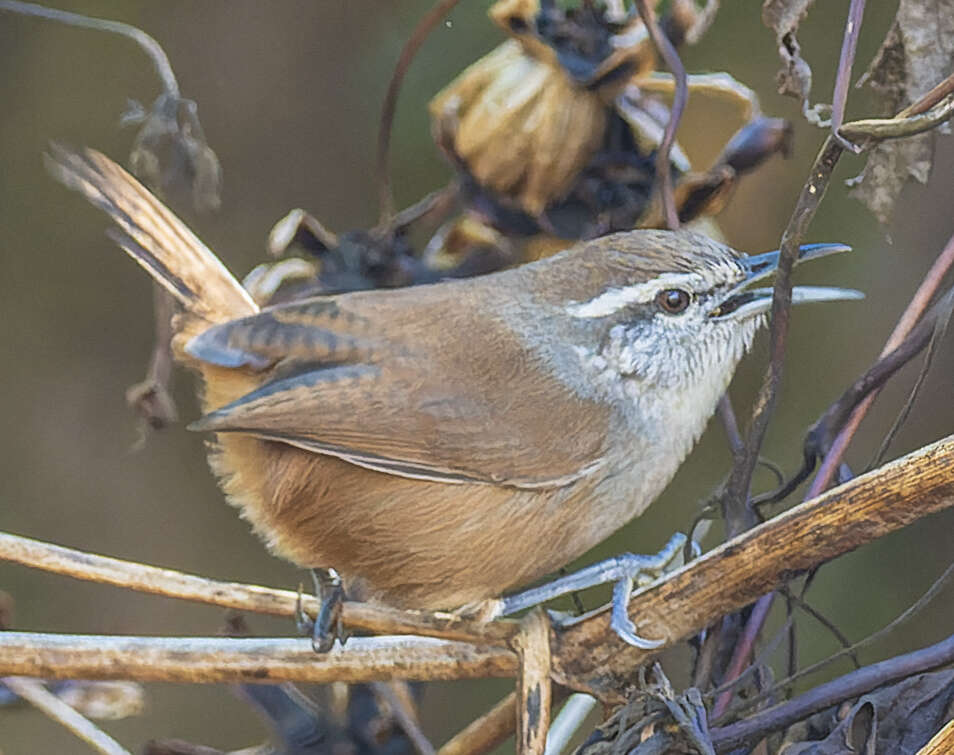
[0,632,517,684]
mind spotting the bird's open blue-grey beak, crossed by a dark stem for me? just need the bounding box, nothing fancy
[709,244,865,320]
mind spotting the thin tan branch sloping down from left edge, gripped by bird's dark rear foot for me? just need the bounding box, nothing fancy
[0,532,519,645]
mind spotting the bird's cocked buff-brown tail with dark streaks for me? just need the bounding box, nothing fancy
[46,145,258,324]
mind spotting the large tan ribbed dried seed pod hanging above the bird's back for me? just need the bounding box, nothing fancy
[430,0,655,217]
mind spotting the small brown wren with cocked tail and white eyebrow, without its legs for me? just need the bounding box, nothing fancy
[47,146,860,648]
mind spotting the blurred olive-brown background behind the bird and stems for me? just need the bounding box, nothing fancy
[0,0,954,755]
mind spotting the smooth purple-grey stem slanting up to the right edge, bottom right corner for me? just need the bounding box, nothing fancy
[710,635,954,752]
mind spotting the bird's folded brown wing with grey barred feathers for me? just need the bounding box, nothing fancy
[187,287,605,488]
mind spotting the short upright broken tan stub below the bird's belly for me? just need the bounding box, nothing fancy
[514,608,552,755]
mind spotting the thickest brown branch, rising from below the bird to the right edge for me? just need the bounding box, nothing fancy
[551,436,954,702]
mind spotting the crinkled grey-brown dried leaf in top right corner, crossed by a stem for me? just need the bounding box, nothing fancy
[850,0,954,223]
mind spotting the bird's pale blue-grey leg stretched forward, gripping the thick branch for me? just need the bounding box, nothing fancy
[500,532,686,650]
